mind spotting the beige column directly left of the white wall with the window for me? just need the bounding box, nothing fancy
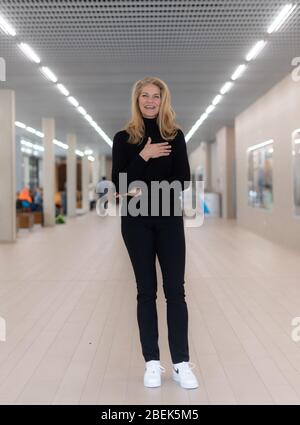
[216,127,236,219]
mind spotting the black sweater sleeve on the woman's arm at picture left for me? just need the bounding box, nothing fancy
[112,131,148,193]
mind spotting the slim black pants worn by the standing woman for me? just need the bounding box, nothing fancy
[121,216,189,363]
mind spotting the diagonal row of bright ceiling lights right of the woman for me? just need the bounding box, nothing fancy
[186,3,297,142]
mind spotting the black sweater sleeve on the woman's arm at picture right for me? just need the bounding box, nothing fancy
[164,130,191,190]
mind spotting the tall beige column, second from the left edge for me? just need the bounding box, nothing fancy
[42,118,55,227]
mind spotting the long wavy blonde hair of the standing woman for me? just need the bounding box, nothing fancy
[124,77,180,144]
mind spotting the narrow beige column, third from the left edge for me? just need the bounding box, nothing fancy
[67,134,77,217]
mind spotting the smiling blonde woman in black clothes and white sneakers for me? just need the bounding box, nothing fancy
[112,77,198,389]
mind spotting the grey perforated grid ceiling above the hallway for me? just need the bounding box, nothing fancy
[0,0,300,155]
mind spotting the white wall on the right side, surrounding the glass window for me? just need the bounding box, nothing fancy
[235,74,300,248]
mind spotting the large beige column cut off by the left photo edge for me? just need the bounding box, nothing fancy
[0,90,16,242]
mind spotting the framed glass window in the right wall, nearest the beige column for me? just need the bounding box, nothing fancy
[247,140,274,210]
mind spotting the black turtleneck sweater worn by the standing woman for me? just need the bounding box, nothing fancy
[112,118,190,216]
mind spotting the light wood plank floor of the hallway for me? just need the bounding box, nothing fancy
[0,213,300,404]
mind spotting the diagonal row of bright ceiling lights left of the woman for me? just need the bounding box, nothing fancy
[0,10,112,156]
